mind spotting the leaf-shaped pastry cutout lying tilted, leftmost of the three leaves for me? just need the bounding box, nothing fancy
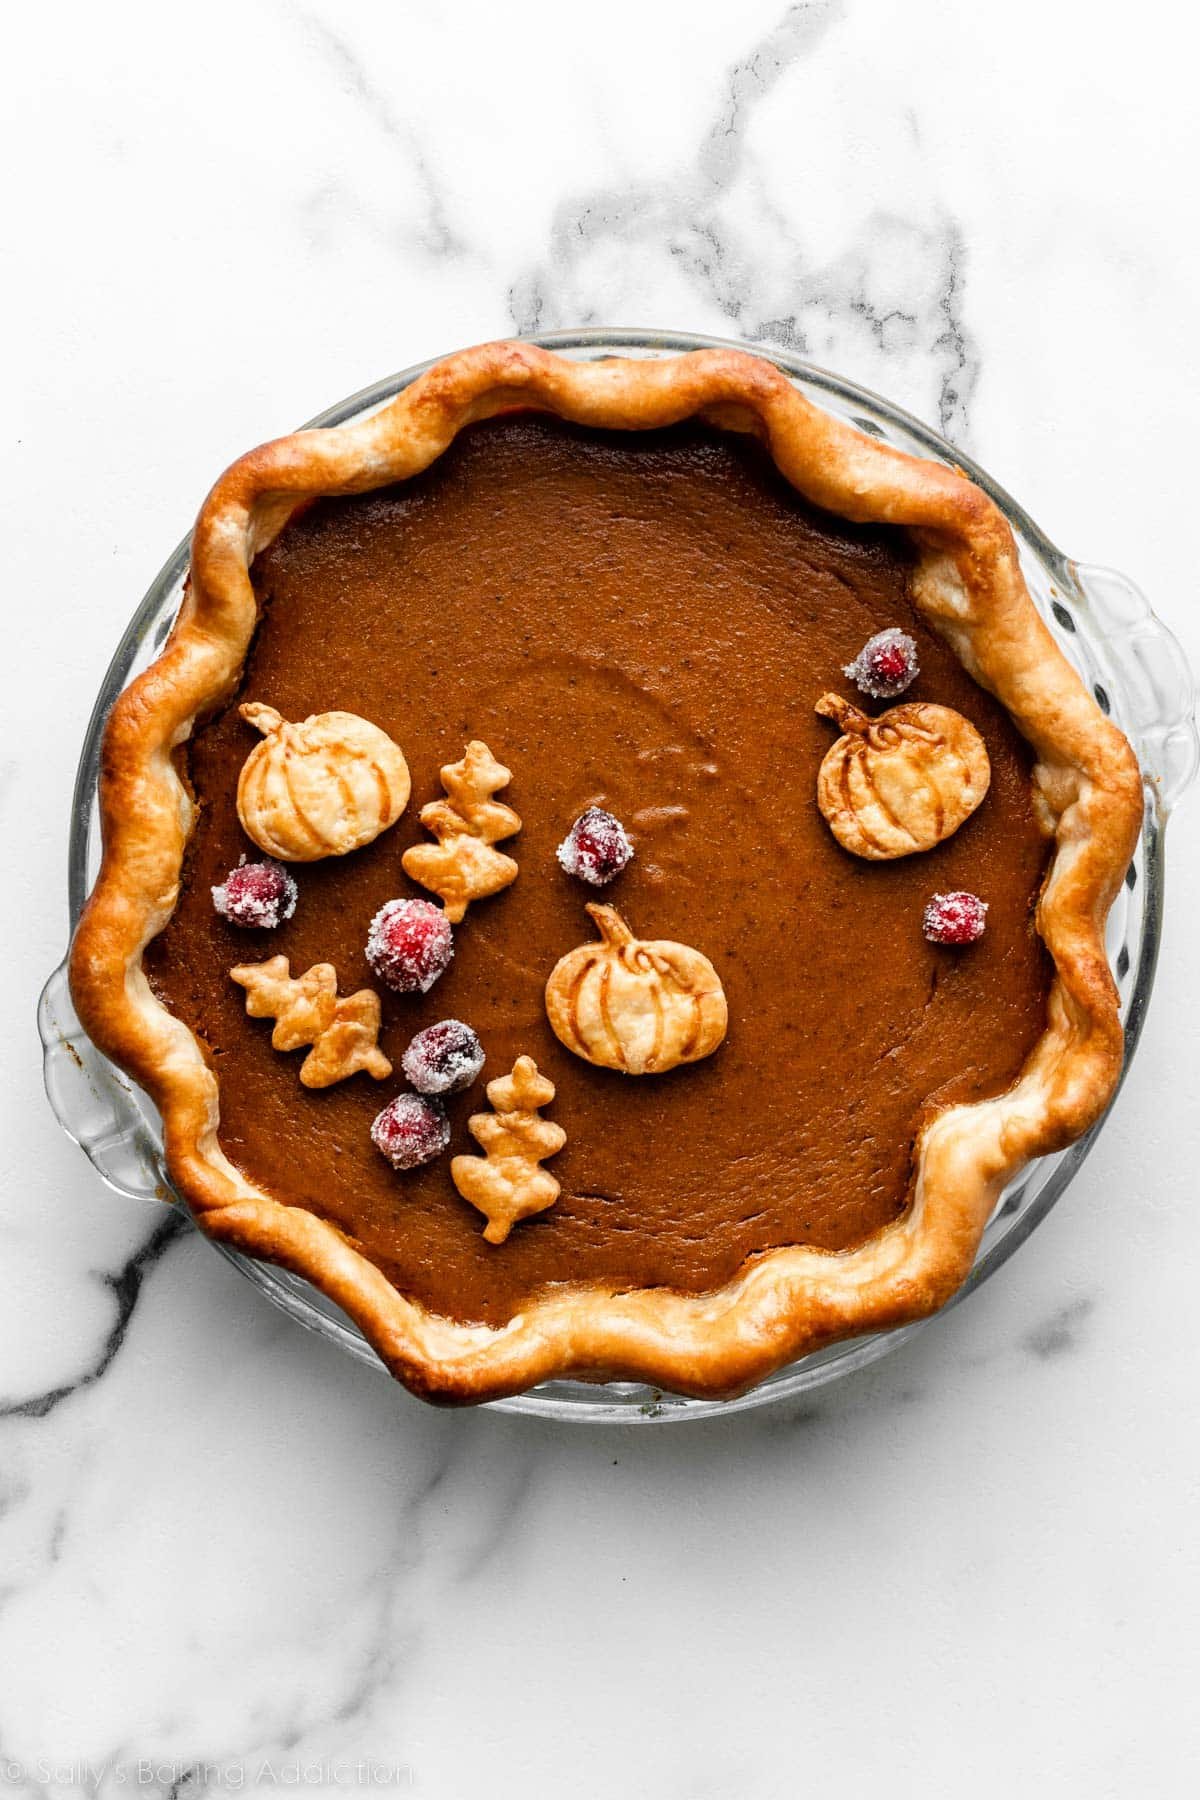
[230,956,392,1087]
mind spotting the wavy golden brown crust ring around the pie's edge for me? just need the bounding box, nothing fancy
[70,344,1141,1402]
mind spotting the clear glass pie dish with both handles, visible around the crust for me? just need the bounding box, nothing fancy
[40,331,1198,1422]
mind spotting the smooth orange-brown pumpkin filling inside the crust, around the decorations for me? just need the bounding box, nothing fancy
[146,416,1052,1325]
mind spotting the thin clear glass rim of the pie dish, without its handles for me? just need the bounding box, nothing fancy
[58,326,1166,1424]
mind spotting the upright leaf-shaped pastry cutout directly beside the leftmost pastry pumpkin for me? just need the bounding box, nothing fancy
[401,738,520,925]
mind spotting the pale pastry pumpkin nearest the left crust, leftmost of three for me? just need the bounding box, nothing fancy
[237,704,412,862]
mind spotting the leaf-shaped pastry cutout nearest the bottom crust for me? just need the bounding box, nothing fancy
[450,1057,567,1244]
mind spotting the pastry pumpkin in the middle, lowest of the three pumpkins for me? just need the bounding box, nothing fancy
[545,904,729,1075]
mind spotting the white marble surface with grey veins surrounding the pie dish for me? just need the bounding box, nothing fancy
[0,0,1200,1800]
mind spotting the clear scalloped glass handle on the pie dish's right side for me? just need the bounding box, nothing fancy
[1070,563,1200,817]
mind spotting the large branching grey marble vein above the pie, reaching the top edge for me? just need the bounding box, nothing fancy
[507,0,981,443]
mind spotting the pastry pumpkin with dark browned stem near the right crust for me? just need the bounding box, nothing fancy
[817,693,991,862]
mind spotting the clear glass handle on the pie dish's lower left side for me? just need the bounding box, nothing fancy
[38,963,171,1201]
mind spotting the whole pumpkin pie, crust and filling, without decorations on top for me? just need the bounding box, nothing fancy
[63,334,1141,1400]
